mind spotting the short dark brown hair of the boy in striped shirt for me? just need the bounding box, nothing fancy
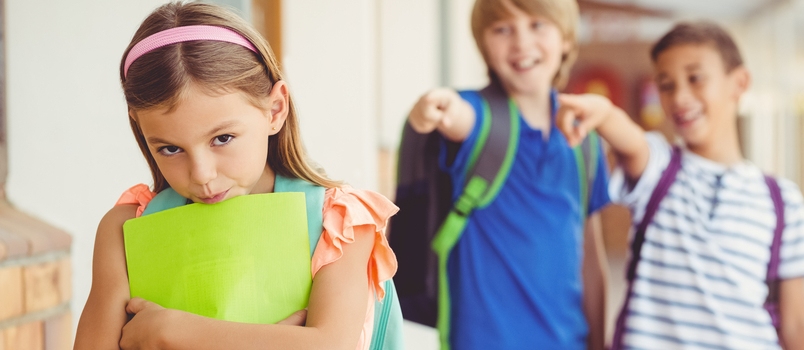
[650,21,743,72]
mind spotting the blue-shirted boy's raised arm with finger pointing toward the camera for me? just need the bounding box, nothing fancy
[408,88,475,142]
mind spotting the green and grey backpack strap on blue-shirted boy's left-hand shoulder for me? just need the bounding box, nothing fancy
[432,84,519,350]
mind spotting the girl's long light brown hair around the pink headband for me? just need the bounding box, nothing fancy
[120,2,339,192]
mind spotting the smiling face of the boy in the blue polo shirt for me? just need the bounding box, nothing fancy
[483,1,572,95]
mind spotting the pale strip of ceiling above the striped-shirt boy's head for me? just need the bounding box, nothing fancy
[578,0,789,20]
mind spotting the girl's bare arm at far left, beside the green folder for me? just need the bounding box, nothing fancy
[74,205,137,350]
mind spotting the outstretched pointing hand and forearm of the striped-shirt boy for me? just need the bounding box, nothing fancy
[556,94,650,182]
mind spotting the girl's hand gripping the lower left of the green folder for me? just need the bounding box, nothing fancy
[120,298,177,350]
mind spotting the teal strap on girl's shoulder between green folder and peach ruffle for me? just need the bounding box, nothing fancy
[274,174,326,256]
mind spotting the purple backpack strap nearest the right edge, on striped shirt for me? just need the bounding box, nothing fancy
[764,175,785,332]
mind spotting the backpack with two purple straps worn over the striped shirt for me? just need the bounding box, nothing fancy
[611,146,785,350]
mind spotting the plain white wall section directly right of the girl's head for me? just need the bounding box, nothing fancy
[282,0,379,190]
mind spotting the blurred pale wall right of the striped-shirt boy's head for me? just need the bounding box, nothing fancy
[729,0,804,185]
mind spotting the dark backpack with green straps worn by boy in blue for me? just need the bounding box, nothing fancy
[389,84,598,349]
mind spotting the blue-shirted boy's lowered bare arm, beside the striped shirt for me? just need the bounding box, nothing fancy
[581,212,608,350]
